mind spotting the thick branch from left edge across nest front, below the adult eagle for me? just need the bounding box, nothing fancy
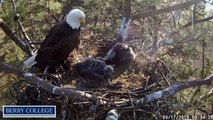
[0,62,96,101]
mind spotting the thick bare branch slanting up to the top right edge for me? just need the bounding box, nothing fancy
[132,0,202,21]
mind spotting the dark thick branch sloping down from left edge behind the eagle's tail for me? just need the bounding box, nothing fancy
[0,18,31,55]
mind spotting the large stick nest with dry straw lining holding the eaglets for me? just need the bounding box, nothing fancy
[17,37,177,120]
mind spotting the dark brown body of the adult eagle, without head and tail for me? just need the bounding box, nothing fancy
[35,21,80,69]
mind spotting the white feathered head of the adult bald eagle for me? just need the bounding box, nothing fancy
[66,9,85,29]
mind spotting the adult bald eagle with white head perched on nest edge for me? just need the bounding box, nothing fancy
[24,9,85,70]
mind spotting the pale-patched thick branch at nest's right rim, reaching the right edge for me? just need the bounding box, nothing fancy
[134,74,213,107]
